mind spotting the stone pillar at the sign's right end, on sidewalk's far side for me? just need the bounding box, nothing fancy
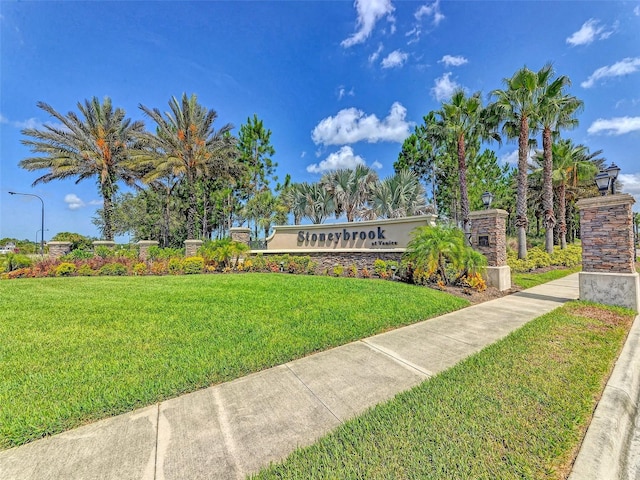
[469,209,511,291]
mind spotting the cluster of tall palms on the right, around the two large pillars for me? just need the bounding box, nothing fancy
[394,65,603,258]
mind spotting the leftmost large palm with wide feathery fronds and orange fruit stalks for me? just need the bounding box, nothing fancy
[19,97,144,240]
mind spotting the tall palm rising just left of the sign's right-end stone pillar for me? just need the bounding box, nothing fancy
[435,90,500,239]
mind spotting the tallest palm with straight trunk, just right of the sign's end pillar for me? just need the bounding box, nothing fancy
[491,65,552,259]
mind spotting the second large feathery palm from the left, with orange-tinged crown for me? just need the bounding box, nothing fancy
[140,93,238,240]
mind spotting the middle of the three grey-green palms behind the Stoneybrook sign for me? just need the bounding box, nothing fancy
[320,165,378,222]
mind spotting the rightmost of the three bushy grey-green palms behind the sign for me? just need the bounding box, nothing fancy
[361,170,433,219]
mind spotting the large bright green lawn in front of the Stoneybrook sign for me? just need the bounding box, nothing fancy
[0,274,467,449]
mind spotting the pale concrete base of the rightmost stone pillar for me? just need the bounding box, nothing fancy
[579,272,640,312]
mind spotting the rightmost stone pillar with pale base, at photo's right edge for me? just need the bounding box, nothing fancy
[576,194,640,311]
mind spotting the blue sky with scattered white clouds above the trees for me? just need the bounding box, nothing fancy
[0,0,640,240]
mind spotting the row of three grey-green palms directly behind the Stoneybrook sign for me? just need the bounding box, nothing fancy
[283,165,431,225]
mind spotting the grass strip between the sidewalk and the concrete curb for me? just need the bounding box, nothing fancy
[255,302,633,480]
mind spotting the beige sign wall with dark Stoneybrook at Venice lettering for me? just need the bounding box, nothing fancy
[260,215,436,253]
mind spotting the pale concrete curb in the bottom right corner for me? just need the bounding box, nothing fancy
[568,315,640,480]
